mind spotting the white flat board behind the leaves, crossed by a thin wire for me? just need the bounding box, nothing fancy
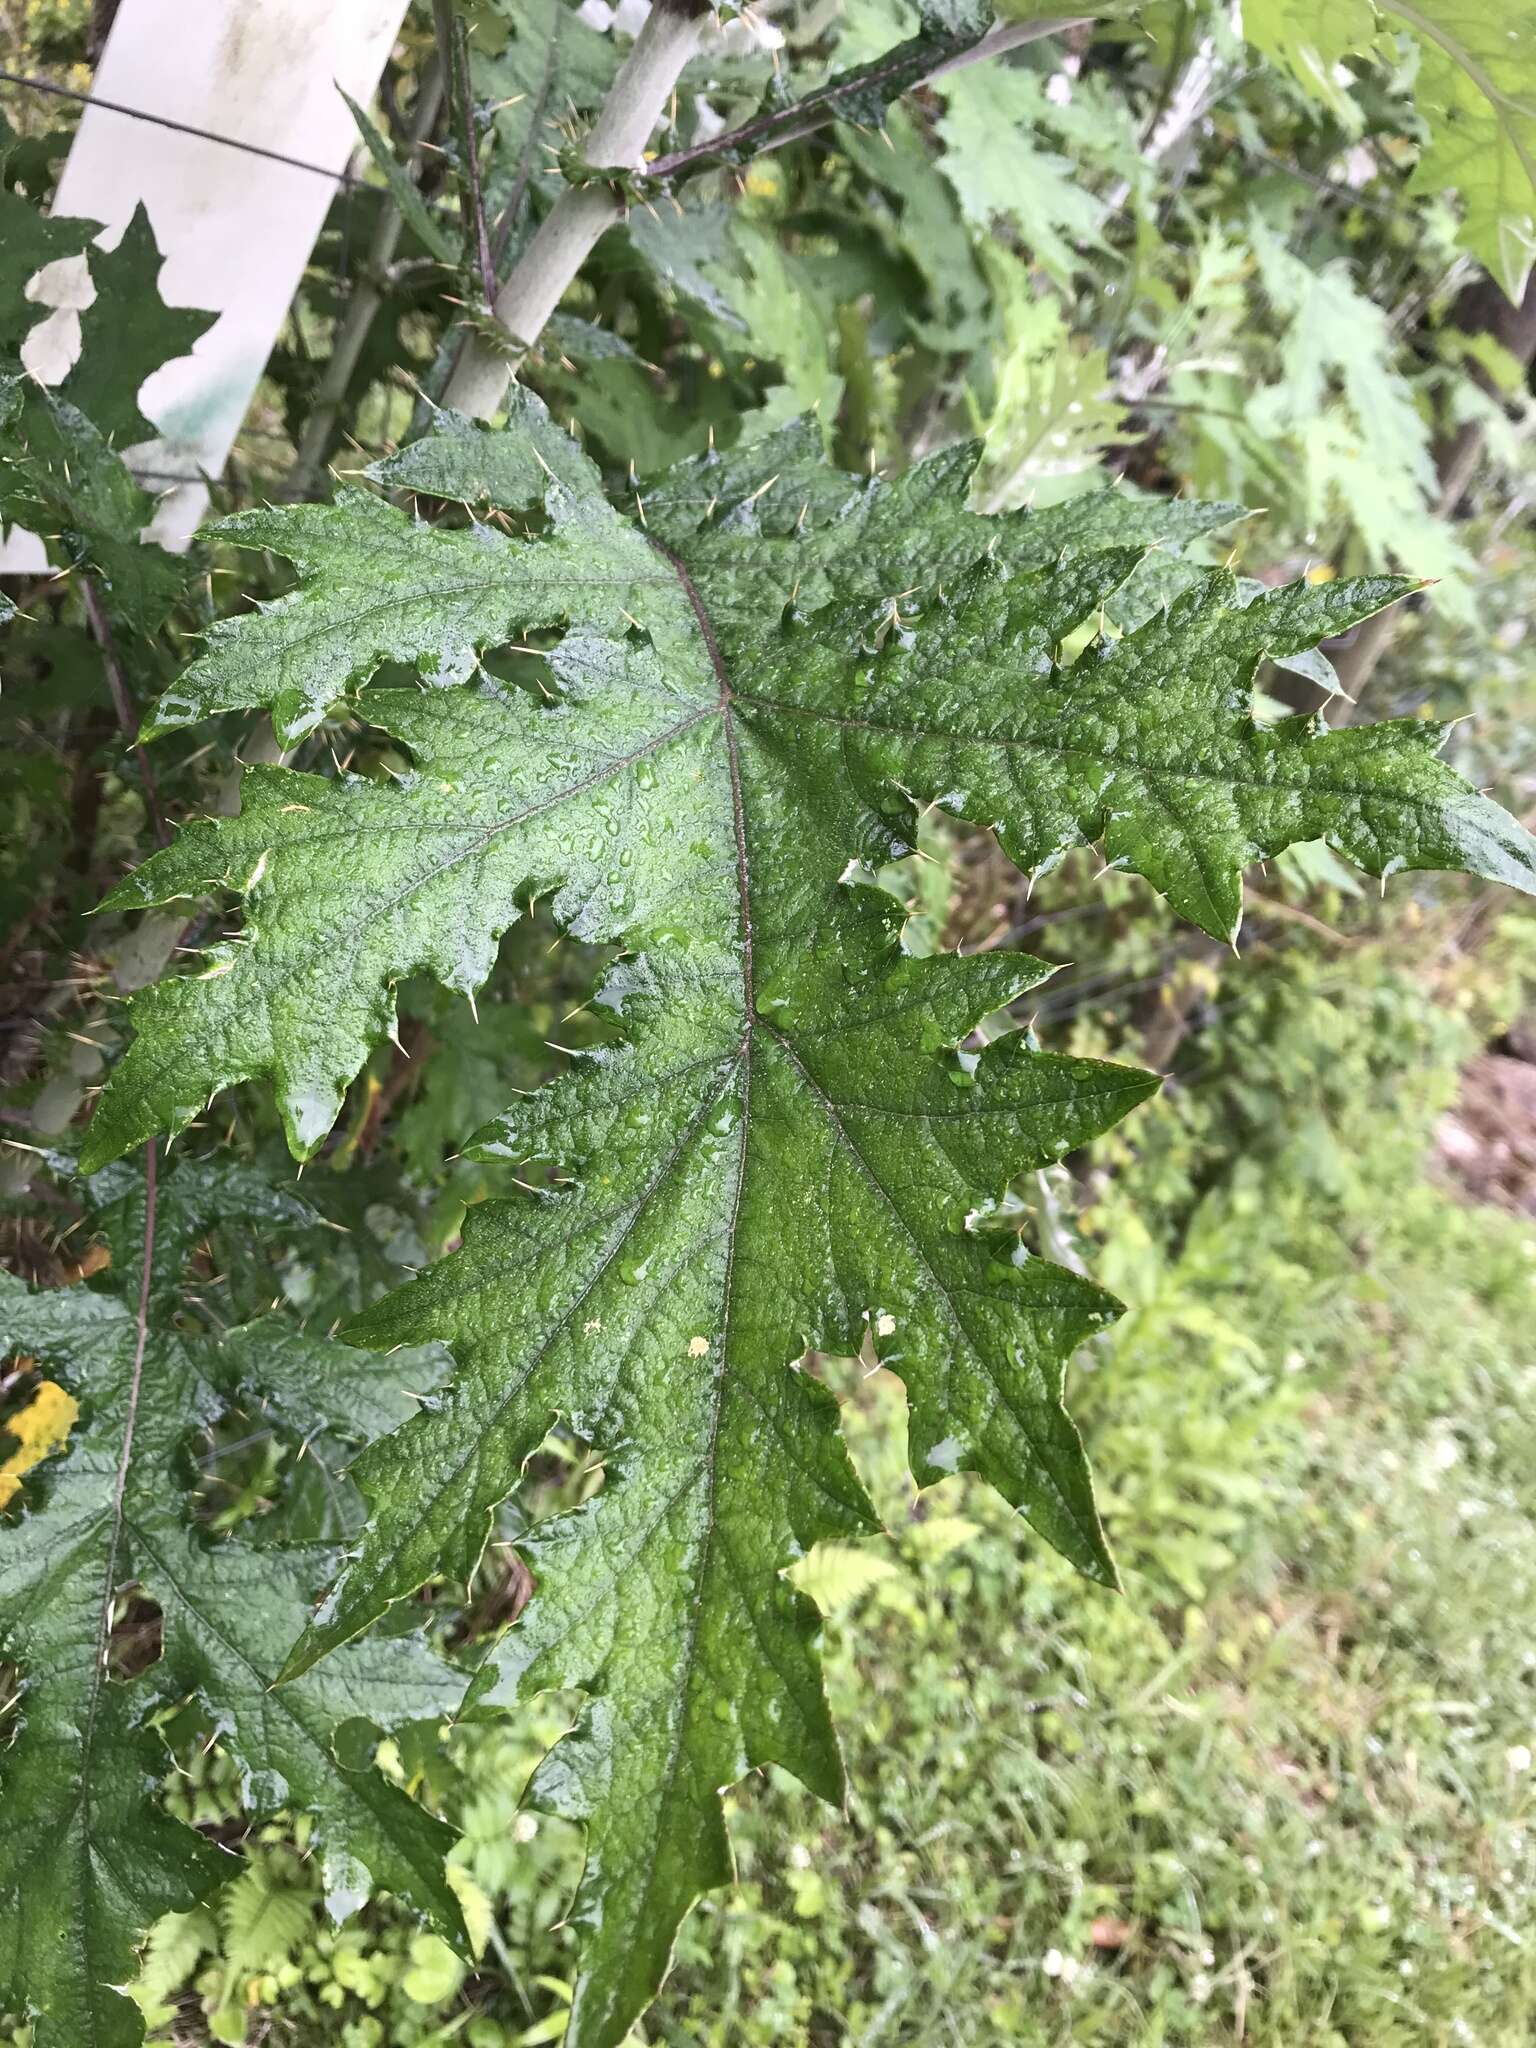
[0,0,415,569]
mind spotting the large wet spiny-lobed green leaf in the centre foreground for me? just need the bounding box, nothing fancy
[86,397,1536,2048]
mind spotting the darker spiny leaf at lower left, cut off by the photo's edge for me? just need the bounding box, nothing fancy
[0,1169,463,2048]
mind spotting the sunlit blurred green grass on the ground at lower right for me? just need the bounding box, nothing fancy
[649,942,1536,2048]
